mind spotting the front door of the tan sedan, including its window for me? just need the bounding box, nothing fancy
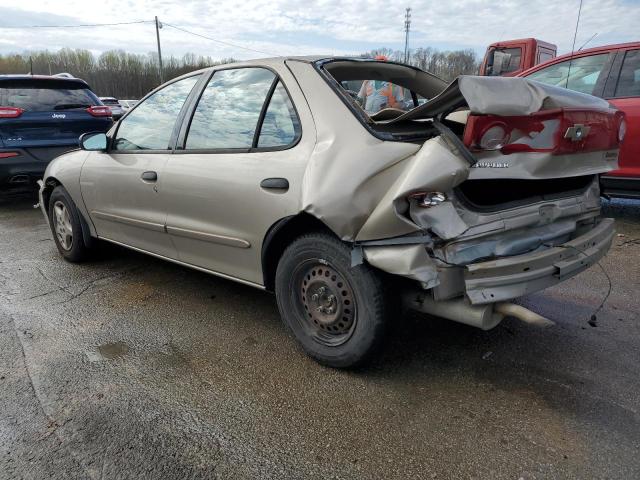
[80,74,202,258]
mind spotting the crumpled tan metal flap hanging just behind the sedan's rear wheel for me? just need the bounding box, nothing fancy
[364,245,440,288]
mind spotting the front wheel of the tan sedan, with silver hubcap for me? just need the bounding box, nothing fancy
[49,185,92,263]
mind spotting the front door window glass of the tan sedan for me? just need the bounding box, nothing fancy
[114,75,200,150]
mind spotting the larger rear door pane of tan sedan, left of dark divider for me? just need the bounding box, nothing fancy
[185,68,276,149]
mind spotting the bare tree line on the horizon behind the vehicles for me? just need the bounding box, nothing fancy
[0,47,479,99]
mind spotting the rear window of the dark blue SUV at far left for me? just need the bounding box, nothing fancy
[0,80,98,112]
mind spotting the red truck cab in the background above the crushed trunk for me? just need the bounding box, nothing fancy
[480,38,558,77]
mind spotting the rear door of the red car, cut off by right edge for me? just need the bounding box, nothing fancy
[604,49,640,178]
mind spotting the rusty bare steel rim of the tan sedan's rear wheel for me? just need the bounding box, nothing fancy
[294,261,357,346]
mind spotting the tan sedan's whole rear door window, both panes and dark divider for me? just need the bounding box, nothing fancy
[185,67,300,150]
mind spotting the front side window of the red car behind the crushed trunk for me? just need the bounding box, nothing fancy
[527,53,609,95]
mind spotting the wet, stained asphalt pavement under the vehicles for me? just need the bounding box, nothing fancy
[0,193,640,479]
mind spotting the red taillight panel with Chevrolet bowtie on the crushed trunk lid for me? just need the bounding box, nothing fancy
[464,109,626,155]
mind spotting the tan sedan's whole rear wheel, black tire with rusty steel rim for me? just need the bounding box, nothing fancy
[275,233,387,368]
